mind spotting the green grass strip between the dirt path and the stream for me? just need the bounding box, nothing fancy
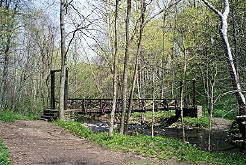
[54,121,246,165]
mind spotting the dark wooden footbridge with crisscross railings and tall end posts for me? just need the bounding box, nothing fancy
[42,70,200,119]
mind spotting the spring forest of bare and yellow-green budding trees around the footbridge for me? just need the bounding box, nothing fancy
[0,0,246,164]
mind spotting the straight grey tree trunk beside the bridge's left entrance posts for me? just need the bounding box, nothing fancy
[59,0,67,120]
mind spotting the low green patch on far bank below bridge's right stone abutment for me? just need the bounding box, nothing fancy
[184,117,209,127]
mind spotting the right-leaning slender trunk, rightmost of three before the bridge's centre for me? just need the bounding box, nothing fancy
[125,0,146,134]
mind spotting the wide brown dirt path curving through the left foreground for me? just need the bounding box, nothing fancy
[0,121,192,165]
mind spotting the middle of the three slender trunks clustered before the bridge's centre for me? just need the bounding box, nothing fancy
[120,0,131,134]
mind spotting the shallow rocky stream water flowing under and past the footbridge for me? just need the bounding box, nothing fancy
[77,116,239,152]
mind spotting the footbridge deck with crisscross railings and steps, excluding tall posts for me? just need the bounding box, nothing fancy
[42,99,197,119]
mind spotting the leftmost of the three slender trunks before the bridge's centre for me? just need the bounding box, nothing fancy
[109,0,119,136]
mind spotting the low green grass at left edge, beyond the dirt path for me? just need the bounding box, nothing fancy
[0,111,38,123]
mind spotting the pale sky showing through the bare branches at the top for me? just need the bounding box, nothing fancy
[29,0,173,62]
